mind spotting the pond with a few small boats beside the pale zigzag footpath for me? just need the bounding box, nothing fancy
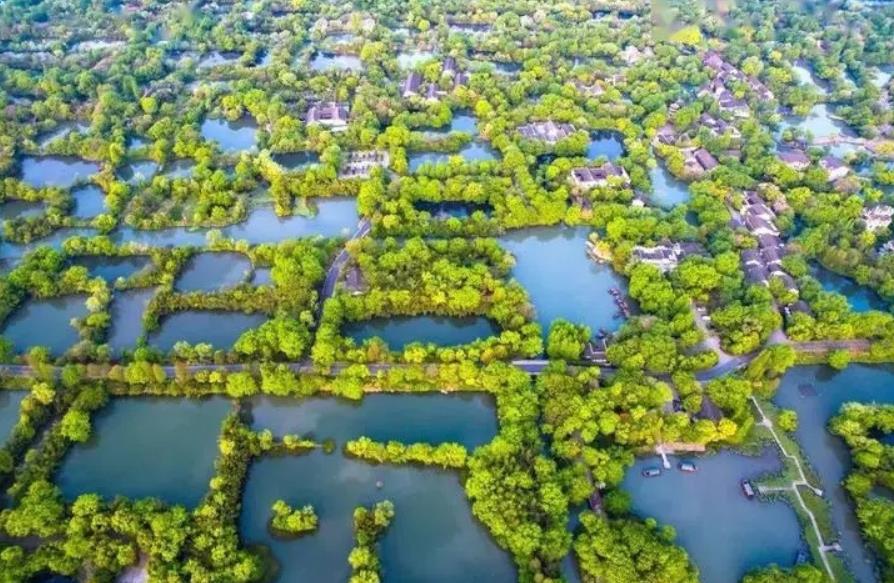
[623,448,803,583]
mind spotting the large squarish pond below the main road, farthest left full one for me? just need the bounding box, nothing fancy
[56,397,231,507]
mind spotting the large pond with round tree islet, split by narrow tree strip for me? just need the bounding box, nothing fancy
[240,394,516,582]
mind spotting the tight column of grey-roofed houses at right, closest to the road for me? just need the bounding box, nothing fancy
[730,191,798,293]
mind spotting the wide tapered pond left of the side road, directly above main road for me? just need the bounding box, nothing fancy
[149,310,267,352]
